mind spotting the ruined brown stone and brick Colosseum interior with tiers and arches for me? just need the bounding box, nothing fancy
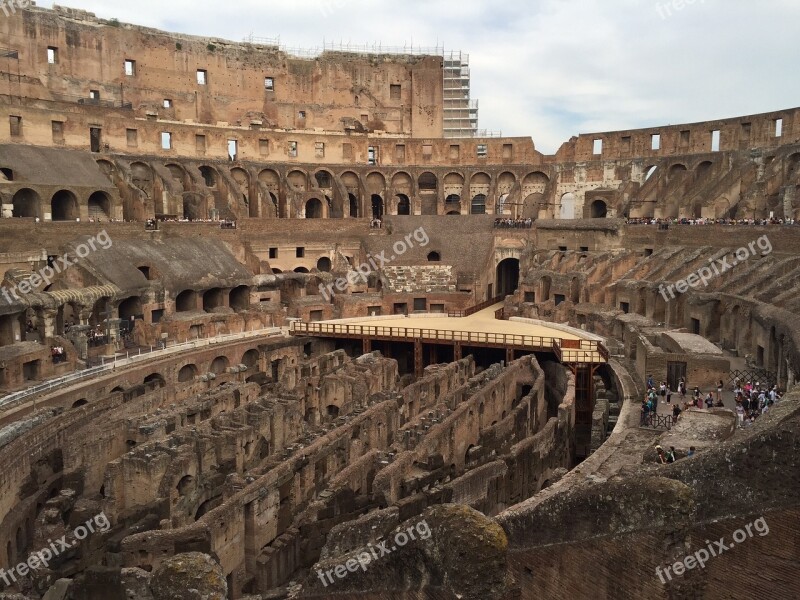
[0,6,800,600]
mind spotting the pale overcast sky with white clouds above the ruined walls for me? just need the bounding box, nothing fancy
[38,0,800,154]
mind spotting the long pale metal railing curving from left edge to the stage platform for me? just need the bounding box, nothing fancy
[0,327,281,407]
